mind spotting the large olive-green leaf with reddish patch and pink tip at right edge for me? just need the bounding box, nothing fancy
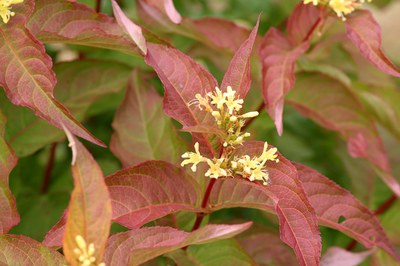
[288,73,400,195]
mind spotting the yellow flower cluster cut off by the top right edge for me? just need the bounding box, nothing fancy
[304,0,372,20]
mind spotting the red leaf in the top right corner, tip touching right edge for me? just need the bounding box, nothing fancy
[345,10,400,77]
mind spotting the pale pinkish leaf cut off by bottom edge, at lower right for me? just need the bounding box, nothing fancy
[321,247,374,266]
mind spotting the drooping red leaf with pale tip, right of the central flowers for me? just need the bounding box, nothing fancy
[260,28,310,135]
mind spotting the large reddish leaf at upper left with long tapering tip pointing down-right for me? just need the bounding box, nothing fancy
[0,14,104,149]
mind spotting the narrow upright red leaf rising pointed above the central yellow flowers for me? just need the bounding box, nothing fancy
[221,17,260,99]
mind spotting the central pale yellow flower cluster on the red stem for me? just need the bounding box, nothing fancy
[181,86,279,185]
